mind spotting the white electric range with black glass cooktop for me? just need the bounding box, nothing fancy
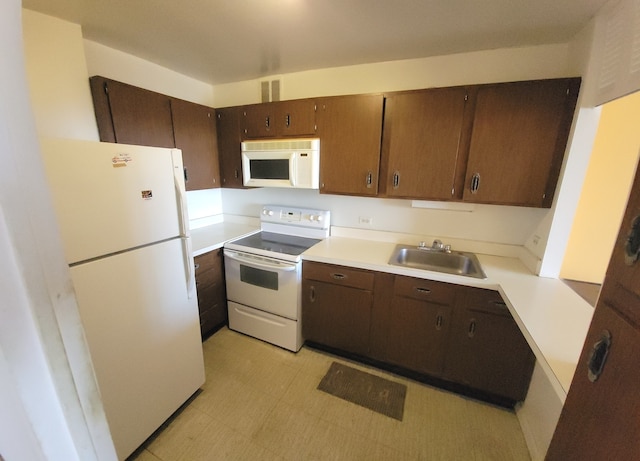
[224,205,331,352]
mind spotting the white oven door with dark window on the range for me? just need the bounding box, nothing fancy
[224,248,302,320]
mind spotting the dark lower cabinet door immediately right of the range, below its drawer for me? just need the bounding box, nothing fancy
[302,279,373,355]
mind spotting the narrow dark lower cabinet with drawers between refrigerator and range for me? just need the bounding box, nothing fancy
[194,249,227,340]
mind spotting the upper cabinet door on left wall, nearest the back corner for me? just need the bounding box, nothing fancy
[171,99,220,190]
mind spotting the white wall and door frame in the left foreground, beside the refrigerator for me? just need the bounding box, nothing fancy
[0,4,115,461]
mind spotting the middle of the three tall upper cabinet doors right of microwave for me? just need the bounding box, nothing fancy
[380,87,467,200]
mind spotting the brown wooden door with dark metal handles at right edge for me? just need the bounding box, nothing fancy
[546,162,640,461]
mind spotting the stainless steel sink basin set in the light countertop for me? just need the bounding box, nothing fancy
[389,245,487,279]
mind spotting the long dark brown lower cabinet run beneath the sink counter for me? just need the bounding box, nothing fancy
[302,261,535,406]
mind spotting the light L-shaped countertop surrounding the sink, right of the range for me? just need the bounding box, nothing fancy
[303,236,593,401]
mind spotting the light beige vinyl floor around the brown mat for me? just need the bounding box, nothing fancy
[130,328,530,461]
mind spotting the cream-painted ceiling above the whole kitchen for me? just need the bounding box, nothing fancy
[22,0,607,85]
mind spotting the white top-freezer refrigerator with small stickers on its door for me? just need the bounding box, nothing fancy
[41,139,205,459]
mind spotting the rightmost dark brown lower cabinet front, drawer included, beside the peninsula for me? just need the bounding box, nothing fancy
[444,288,535,402]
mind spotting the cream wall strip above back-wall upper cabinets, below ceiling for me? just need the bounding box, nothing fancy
[214,44,577,107]
